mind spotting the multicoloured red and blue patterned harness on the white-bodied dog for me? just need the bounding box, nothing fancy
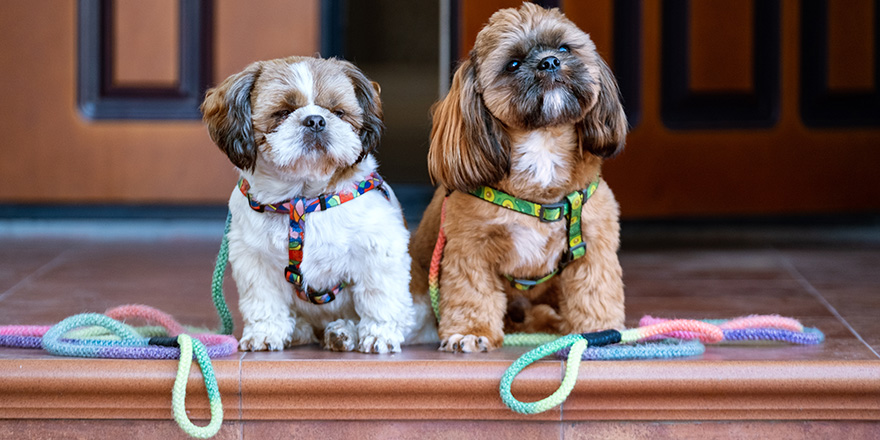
[238,172,389,305]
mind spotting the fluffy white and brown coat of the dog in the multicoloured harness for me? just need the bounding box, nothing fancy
[201,57,436,353]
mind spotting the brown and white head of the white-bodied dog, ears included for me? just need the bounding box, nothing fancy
[201,57,384,179]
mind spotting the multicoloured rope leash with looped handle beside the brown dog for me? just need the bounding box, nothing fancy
[499,315,824,414]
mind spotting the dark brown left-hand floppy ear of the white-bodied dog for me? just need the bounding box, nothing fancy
[200,62,261,170]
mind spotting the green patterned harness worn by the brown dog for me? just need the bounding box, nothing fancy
[470,178,599,290]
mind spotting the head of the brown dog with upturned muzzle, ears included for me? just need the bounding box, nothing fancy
[428,3,627,191]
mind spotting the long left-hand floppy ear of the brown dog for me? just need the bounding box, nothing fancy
[428,60,510,191]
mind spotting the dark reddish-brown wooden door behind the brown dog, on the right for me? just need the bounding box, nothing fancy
[456,0,880,218]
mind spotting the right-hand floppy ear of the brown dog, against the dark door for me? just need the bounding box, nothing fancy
[577,54,627,157]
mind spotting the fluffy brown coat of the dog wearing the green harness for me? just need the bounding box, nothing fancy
[411,3,627,352]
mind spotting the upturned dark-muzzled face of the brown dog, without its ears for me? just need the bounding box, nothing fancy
[471,5,599,130]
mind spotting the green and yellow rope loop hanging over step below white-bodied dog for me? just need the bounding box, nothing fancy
[171,334,223,438]
